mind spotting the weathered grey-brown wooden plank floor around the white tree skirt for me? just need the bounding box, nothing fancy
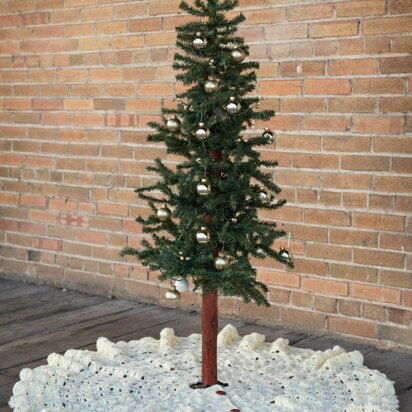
[0,278,412,412]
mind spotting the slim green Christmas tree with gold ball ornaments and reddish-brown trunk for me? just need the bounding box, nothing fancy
[122,0,292,387]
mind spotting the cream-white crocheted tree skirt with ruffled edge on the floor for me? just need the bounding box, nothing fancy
[10,325,398,412]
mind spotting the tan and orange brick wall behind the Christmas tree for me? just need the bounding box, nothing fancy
[0,0,412,349]
